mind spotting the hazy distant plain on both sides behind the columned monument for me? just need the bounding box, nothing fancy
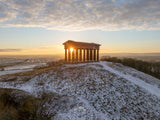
[0,53,160,75]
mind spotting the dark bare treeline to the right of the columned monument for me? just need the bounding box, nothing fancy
[101,56,160,79]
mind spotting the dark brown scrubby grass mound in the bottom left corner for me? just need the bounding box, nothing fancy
[0,88,50,120]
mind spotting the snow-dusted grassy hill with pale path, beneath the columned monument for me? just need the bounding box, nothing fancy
[0,62,160,120]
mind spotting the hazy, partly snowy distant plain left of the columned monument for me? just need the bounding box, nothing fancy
[0,55,61,75]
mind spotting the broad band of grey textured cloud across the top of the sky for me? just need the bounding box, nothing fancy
[0,0,160,31]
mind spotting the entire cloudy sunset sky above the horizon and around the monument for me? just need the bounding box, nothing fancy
[0,0,160,55]
